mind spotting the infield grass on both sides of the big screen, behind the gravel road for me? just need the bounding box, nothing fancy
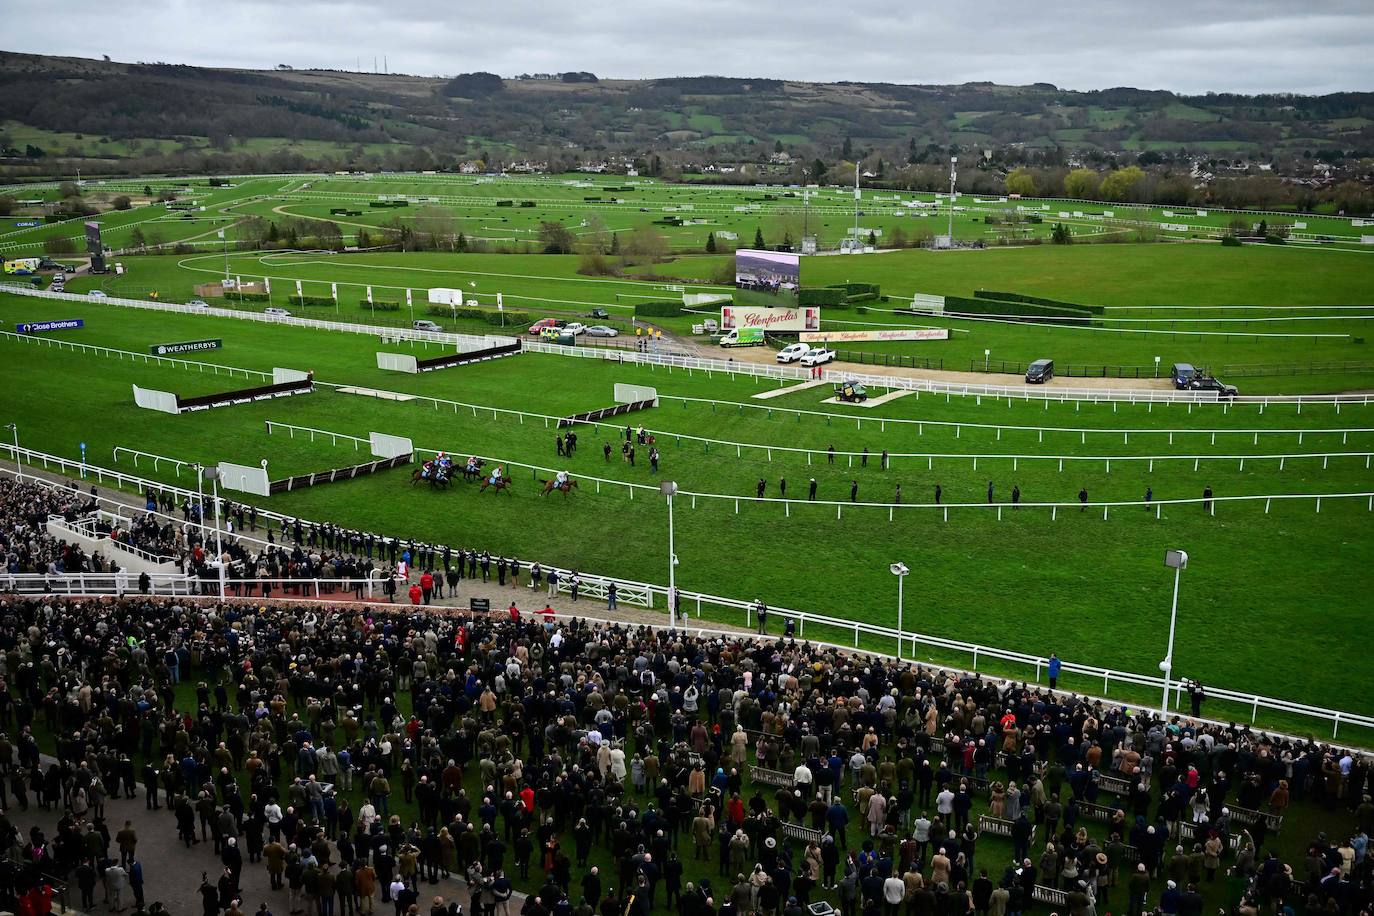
[69,238,1374,394]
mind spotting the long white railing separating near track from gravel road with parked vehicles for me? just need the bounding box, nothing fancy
[0,280,1371,405]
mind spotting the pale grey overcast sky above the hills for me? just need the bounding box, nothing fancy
[4,0,1374,93]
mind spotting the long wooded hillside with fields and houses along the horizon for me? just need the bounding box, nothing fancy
[0,54,1374,177]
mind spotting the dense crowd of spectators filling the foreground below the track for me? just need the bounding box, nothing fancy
[0,483,1374,916]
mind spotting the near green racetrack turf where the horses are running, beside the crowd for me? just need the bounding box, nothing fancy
[0,297,1374,747]
